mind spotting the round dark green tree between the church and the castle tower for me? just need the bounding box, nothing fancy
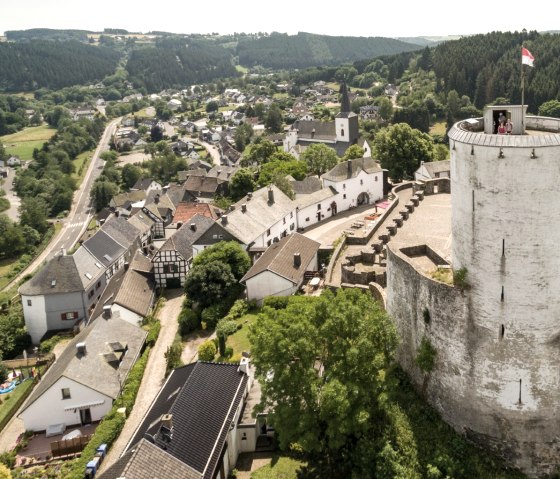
[374,123,434,182]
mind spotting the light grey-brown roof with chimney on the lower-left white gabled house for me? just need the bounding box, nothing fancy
[22,315,147,411]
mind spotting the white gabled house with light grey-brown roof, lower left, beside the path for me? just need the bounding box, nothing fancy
[19,314,147,434]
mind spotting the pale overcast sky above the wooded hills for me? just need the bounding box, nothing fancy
[0,0,558,37]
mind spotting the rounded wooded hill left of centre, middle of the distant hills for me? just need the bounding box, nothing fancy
[126,39,237,91]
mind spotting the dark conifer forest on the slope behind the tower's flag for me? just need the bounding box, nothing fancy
[431,32,560,109]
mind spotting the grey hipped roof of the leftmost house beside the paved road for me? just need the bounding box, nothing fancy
[19,255,84,296]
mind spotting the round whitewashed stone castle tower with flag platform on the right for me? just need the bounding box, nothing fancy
[387,105,560,477]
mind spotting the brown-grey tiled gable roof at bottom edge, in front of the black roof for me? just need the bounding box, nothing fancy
[99,439,202,479]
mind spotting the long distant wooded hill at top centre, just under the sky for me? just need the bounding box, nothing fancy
[237,32,422,69]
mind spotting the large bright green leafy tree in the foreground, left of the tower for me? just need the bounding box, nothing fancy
[249,289,397,478]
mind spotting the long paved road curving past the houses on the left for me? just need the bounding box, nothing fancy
[5,118,121,289]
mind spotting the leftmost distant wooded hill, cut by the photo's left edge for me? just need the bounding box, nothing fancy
[0,40,120,92]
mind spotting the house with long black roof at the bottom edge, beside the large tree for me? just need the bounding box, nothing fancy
[104,358,274,479]
